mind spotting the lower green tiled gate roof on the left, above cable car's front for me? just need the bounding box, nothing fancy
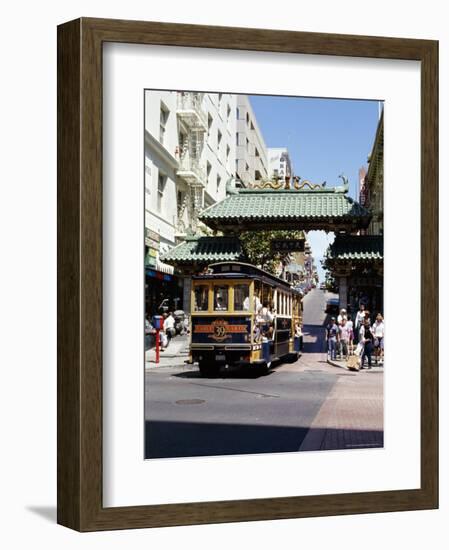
[161,237,245,265]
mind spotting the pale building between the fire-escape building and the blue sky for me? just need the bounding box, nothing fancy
[235,95,269,187]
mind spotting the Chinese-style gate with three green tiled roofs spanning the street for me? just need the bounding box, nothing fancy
[162,177,383,314]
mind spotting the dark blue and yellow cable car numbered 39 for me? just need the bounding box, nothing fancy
[190,262,302,376]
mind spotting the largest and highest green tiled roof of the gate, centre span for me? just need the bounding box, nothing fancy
[199,189,371,233]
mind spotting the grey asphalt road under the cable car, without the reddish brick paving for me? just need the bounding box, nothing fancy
[145,290,338,458]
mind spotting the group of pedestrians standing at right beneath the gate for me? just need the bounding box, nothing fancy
[326,304,385,369]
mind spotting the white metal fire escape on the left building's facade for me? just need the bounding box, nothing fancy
[176,92,208,233]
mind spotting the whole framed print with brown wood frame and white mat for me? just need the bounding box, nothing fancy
[58,18,438,531]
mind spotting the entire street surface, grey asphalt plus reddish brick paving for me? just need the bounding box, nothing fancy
[145,289,383,458]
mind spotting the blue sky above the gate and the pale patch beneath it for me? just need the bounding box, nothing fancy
[249,95,379,281]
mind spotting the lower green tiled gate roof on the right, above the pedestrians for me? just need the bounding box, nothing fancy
[327,235,384,261]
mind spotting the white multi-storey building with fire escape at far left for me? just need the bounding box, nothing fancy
[145,90,237,312]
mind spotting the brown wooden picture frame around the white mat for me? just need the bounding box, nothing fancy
[58,18,438,531]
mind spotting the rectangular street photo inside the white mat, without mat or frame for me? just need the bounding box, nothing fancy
[142,89,382,459]
